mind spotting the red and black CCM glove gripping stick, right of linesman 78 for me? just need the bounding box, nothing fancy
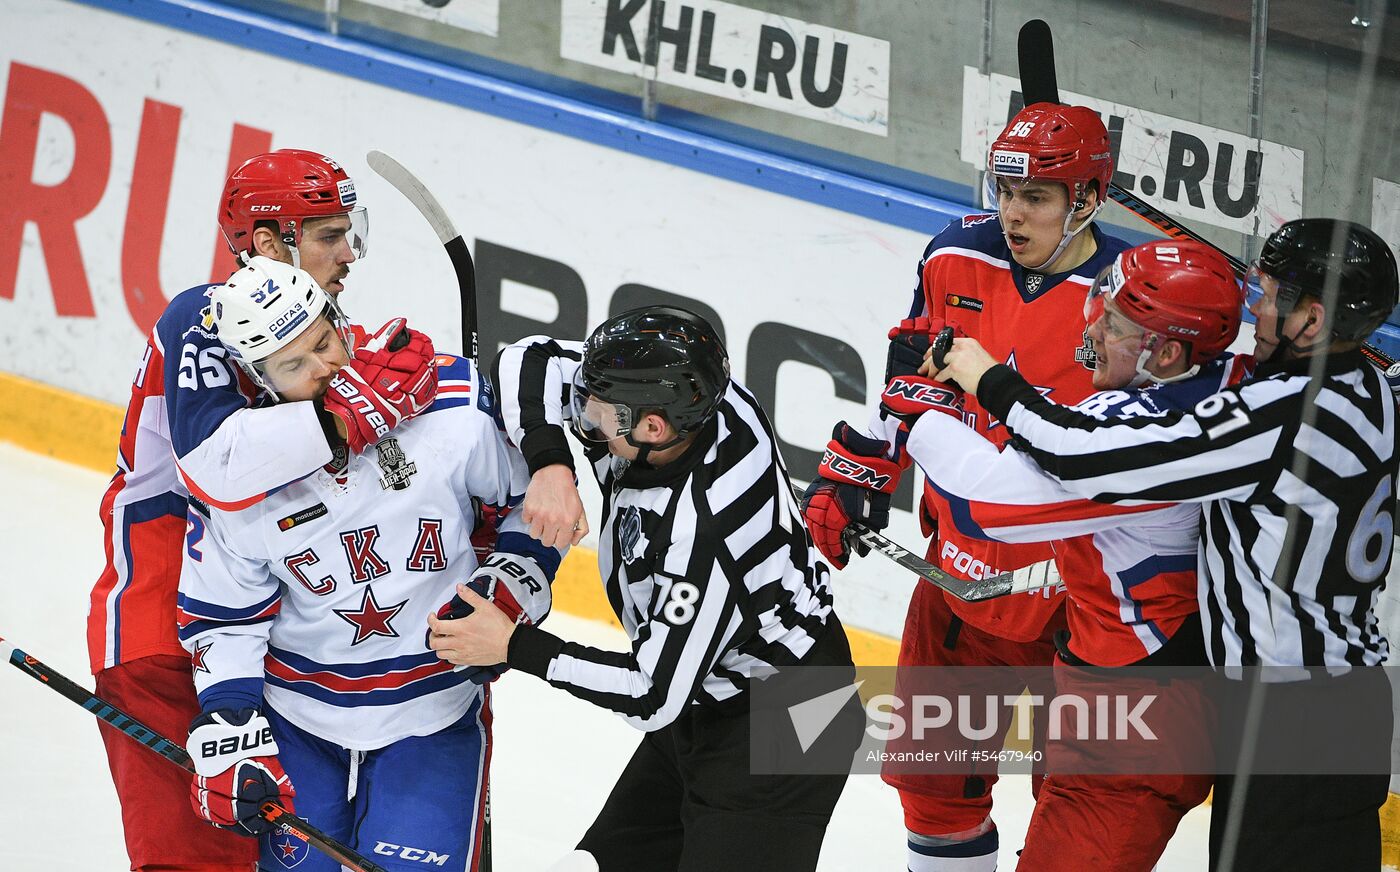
[802,421,900,570]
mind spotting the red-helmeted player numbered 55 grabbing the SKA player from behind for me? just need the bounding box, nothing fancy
[87,148,437,872]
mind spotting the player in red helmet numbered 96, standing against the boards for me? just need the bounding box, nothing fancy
[804,104,1127,872]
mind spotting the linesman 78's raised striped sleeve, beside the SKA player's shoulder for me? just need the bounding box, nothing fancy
[491,336,582,474]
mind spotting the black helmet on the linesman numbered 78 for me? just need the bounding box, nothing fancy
[574,305,729,442]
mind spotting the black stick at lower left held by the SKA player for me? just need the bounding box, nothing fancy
[0,638,386,872]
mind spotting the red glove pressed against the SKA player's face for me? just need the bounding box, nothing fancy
[322,318,437,453]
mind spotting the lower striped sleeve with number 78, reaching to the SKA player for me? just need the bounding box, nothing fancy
[508,509,741,732]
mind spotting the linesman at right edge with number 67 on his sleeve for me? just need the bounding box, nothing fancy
[931,218,1397,872]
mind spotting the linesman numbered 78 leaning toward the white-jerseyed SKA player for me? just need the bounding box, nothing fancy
[430,307,864,872]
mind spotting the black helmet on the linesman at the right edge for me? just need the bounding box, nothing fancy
[1259,218,1400,340]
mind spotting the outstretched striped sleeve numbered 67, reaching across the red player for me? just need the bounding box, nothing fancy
[977,365,1302,502]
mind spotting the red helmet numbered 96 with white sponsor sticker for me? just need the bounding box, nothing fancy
[987,104,1113,211]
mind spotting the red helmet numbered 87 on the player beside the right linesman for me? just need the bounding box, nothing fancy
[1086,239,1245,367]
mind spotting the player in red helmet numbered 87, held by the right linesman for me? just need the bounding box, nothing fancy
[886,241,1253,872]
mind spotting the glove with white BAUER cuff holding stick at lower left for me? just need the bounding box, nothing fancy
[188,708,297,836]
